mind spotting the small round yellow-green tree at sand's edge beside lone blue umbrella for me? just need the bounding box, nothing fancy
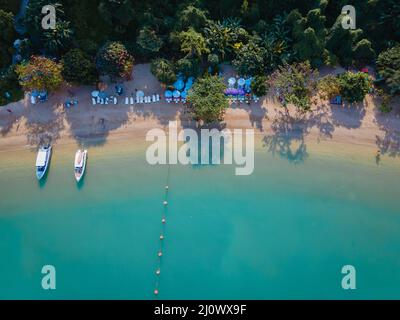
[339,72,372,103]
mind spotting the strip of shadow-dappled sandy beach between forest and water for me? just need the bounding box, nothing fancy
[0,64,400,162]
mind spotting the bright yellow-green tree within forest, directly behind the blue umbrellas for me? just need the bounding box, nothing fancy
[179,28,209,60]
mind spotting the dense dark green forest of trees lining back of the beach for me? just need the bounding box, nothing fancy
[0,0,400,118]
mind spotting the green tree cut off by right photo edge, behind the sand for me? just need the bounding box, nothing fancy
[376,45,400,95]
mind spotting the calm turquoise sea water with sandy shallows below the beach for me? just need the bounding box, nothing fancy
[0,142,400,299]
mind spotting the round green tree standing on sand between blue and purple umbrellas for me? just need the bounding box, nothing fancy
[188,75,229,123]
